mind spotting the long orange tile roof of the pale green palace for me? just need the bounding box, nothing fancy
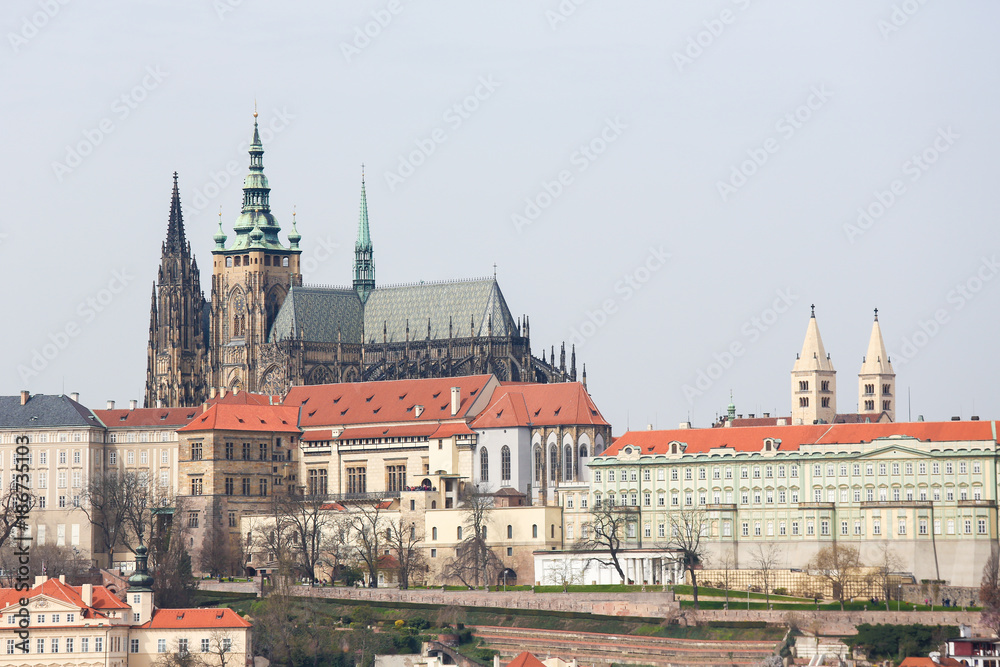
[604,421,994,456]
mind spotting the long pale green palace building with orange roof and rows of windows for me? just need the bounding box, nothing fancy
[589,421,998,586]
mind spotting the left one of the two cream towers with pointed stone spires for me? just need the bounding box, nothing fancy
[792,306,837,424]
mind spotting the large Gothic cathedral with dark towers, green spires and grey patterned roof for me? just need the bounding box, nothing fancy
[145,113,587,407]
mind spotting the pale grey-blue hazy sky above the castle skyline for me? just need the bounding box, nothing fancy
[0,0,1000,433]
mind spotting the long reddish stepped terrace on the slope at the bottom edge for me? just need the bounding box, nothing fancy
[473,626,781,667]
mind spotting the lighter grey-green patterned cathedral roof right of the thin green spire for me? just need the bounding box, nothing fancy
[365,278,517,343]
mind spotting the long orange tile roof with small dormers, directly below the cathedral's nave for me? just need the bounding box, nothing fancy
[284,375,493,427]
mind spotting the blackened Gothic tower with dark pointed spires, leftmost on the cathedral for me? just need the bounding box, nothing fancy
[145,172,206,408]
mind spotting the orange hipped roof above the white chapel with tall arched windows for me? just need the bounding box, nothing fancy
[472,382,608,428]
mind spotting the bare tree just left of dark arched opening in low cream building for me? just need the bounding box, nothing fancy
[445,485,504,587]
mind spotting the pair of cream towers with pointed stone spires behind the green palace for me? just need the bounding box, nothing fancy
[792,306,896,424]
